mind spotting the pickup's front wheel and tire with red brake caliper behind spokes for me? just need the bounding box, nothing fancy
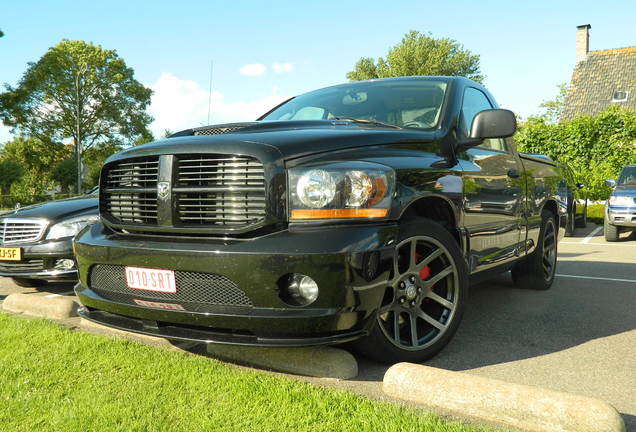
[353,218,468,364]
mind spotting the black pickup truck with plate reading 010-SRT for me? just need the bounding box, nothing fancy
[74,77,567,363]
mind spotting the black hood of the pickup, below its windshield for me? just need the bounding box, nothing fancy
[107,120,440,162]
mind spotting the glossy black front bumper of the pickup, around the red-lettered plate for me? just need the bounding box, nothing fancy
[75,224,397,346]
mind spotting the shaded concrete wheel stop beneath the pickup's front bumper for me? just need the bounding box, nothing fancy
[207,344,358,379]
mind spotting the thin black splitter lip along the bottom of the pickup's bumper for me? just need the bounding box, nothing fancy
[78,307,368,347]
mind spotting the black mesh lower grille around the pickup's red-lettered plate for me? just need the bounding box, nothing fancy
[90,264,252,307]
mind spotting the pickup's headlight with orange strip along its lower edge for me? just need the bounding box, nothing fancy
[289,162,395,220]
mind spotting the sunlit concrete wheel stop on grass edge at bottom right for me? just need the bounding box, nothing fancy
[383,363,625,432]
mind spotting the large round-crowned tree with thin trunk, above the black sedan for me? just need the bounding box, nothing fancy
[0,40,152,192]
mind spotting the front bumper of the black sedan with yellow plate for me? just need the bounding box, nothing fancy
[0,238,78,282]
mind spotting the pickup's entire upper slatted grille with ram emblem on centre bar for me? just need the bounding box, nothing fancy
[100,154,267,233]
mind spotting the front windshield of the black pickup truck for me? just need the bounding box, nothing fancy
[261,78,446,129]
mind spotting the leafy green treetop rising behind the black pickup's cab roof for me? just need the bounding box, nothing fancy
[347,30,483,82]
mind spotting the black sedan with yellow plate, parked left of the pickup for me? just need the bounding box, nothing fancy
[0,188,99,286]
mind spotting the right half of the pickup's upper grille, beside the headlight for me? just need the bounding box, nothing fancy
[176,155,265,226]
